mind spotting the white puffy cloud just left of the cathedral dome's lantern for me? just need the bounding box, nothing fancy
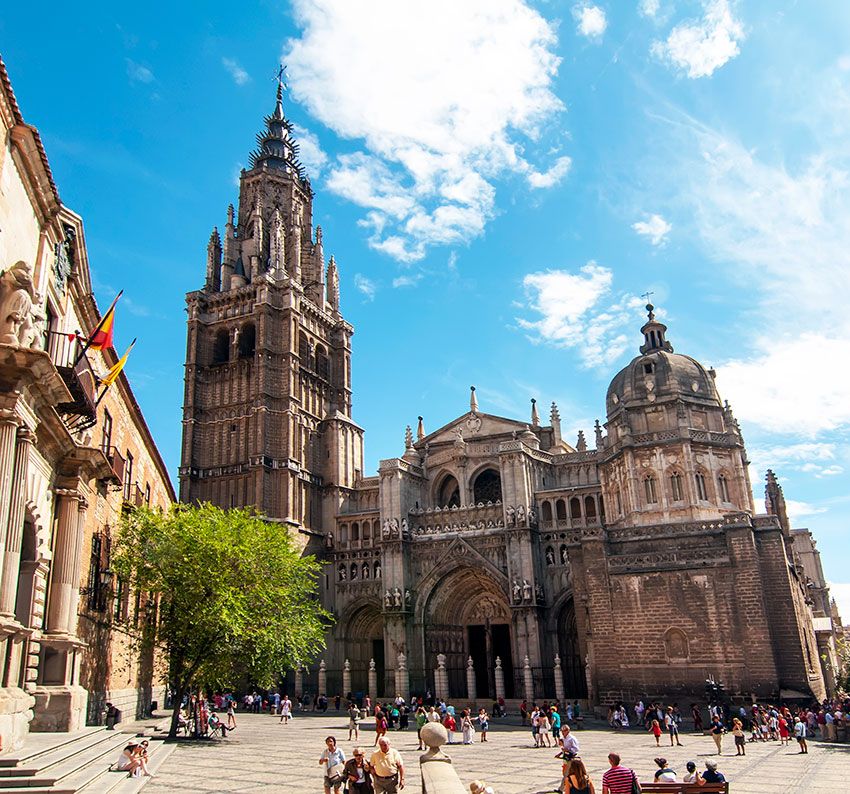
[517,262,641,367]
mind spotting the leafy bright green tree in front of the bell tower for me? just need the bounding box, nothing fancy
[113,504,331,737]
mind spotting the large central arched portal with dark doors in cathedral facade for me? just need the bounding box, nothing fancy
[424,567,514,698]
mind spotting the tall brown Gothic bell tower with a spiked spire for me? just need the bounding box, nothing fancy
[180,79,363,534]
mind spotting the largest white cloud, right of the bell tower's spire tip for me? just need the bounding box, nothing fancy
[285,0,568,262]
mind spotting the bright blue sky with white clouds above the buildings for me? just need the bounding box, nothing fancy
[0,0,850,617]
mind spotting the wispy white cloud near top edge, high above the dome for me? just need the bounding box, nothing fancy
[652,0,744,79]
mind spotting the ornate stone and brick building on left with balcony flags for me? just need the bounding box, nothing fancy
[0,55,174,750]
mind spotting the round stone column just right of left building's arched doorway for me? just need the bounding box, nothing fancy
[47,488,81,634]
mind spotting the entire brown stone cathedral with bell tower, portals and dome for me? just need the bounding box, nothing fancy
[180,87,825,704]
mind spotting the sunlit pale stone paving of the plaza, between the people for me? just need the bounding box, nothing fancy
[146,711,850,794]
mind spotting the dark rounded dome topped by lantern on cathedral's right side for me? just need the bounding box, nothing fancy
[606,304,721,416]
